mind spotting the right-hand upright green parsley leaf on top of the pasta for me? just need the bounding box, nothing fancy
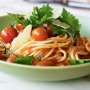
[58,8,81,37]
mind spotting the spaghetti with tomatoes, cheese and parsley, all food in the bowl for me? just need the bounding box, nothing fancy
[0,4,90,66]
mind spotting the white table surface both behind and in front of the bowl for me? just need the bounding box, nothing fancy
[0,0,90,90]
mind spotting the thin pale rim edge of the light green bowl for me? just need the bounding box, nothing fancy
[0,15,90,69]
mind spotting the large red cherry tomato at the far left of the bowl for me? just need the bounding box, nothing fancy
[1,26,18,43]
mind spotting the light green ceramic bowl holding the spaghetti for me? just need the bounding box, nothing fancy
[0,16,90,81]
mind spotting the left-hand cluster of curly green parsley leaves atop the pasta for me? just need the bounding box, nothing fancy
[8,4,53,28]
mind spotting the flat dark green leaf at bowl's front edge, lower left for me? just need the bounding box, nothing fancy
[13,55,34,65]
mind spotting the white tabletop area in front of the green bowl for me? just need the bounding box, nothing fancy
[0,73,90,90]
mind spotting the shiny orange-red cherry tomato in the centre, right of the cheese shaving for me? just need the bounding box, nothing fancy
[32,28,48,41]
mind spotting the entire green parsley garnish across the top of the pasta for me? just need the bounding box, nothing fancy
[9,4,81,38]
